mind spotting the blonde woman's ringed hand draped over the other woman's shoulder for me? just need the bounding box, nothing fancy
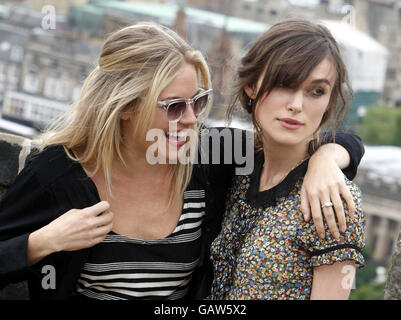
[301,144,355,239]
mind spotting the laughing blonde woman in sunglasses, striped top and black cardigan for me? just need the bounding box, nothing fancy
[0,23,360,299]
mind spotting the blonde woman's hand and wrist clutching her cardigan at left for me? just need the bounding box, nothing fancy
[28,201,113,265]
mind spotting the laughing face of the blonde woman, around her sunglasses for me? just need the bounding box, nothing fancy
[123,63,199,163]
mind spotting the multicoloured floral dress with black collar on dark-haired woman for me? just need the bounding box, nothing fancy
[209,153,366,300]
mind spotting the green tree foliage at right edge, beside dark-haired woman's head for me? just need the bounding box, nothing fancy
[357,106,401,146]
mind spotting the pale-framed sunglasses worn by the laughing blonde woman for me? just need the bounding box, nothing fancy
[157,89,213,122]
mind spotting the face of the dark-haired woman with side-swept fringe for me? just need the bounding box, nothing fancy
[250,58,336,146]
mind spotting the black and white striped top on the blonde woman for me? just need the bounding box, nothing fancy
[76,190,205,300]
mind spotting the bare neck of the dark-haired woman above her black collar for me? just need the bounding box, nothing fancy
[259,141,308,191]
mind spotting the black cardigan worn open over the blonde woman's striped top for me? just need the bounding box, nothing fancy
[0,129,364,299]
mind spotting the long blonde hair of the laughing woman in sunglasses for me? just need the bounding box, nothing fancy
[41,22,211,208]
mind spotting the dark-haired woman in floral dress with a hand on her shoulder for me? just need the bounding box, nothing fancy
[211,20,365,299]
